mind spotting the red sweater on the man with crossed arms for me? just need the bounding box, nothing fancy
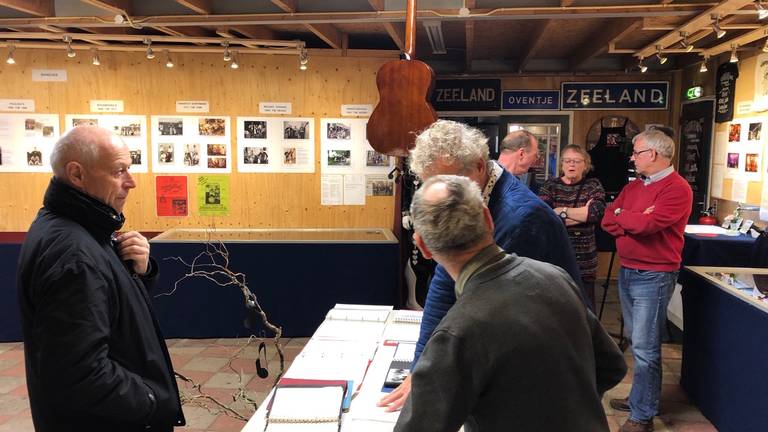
[602,171,693,271]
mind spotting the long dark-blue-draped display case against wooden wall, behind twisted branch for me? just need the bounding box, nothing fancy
[150,228,400,338]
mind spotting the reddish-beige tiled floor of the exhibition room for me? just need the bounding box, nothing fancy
[0,288,716,432]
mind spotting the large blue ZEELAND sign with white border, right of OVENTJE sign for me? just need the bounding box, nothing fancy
[561,81,669,110]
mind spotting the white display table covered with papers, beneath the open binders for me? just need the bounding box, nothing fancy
[242,305,419,432]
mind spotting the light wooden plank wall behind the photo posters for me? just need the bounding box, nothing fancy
[0,50,394,231]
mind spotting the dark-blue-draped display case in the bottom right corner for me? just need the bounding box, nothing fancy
[680,267,768,432]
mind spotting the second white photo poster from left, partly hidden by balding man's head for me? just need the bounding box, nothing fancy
[64,114,149,173]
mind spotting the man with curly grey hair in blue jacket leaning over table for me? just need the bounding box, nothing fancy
[379,120,586,411]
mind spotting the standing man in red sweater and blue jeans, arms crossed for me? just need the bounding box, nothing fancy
[602,130,693,432]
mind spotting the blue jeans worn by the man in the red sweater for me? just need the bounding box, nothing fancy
[619,267,678,422]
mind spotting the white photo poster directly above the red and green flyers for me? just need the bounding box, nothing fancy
[152,115,232,173]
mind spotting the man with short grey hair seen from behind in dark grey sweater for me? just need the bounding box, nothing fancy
[394,175,626,432]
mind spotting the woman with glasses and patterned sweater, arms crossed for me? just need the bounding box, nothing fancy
[539,144,605,310]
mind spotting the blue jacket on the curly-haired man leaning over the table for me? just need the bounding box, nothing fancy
[413,165,586,365]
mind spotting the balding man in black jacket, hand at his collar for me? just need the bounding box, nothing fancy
[17,126,185,432]
